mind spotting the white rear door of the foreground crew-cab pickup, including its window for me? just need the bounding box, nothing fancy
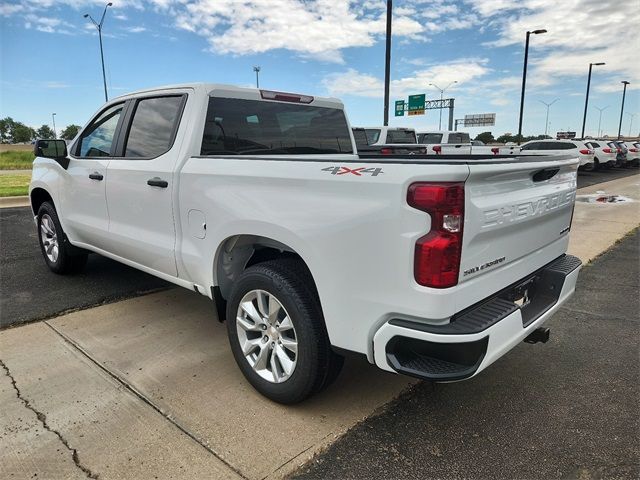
[106,91,187,276]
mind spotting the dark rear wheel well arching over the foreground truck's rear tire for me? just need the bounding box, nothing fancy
[212,235,317,321]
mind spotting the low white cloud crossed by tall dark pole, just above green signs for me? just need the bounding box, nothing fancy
[322,58,490,98]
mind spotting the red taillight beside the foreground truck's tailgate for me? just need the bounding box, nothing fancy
[407,183,464,288]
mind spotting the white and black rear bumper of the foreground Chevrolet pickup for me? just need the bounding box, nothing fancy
[373,255,581,382]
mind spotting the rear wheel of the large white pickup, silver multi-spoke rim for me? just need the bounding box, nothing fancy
[227,258,343,404]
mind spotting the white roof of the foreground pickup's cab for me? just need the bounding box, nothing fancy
[111,82,343,108]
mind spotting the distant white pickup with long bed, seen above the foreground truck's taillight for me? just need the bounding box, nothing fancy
[417,130,520,155]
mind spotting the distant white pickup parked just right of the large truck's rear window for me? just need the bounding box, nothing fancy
[352,127,427,155]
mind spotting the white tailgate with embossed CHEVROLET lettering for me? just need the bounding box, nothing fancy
[459,157,579,282]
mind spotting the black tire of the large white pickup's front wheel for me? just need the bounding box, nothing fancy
[38,202,87,275]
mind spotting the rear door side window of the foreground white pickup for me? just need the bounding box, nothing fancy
[124,95,184,158]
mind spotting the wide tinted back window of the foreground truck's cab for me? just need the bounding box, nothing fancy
[201,97,353,155]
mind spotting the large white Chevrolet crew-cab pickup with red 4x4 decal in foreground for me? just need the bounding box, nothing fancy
[29,84,580,403]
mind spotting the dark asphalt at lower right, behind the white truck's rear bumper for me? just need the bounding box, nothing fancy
[294,230,640,479]
